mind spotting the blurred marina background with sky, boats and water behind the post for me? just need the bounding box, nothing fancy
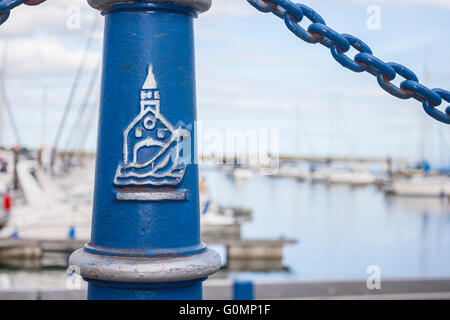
[0,0,450,300]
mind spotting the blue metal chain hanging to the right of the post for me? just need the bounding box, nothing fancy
[247,0,450,124]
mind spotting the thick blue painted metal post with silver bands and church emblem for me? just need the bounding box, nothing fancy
[70,0,220,299]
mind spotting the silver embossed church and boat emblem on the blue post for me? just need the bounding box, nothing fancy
[114,65,190,200]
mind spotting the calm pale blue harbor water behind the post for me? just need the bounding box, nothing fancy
[0,168,450,289]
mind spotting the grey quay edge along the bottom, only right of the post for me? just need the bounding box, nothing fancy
[203,278,450,300]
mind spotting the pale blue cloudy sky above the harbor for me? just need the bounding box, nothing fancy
[0,0,450,165]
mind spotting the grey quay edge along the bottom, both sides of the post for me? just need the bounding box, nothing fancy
[0,278,450,300]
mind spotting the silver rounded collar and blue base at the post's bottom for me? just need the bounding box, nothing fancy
[69,248,221,300]
